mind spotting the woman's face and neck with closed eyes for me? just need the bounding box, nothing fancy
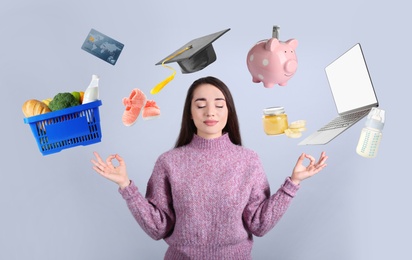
[191,84,228,139]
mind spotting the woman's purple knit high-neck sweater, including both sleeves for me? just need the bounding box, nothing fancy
[119,134,299,260]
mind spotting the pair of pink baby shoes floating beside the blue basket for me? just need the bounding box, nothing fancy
[122,88,160,126]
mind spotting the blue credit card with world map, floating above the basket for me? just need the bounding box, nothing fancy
[82,29,124,65]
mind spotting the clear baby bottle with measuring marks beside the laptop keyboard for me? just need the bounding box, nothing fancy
[356,107,385,158]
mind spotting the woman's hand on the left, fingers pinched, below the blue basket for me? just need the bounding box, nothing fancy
[91,152,130,189]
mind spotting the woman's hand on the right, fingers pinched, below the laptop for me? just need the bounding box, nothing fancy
[290,152,328,185]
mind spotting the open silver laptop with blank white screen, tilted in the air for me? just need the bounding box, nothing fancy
[298,43,379,145]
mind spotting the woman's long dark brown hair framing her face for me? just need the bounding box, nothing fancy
[175,76,242,148]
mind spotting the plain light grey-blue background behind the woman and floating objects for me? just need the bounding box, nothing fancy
[0,0,412,260]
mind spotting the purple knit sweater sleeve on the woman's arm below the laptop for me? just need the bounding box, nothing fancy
[243,153,300,236]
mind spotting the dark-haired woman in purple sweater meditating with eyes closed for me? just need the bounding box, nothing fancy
[92,77,327,260]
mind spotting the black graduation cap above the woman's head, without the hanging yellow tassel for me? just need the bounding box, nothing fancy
[156,28,230,73]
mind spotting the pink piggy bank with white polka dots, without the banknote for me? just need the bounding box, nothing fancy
[247,38,298,88]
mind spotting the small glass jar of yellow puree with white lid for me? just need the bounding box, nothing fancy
[262,107,288,135]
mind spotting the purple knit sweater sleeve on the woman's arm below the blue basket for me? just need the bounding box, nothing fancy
[119,155,175,240]
